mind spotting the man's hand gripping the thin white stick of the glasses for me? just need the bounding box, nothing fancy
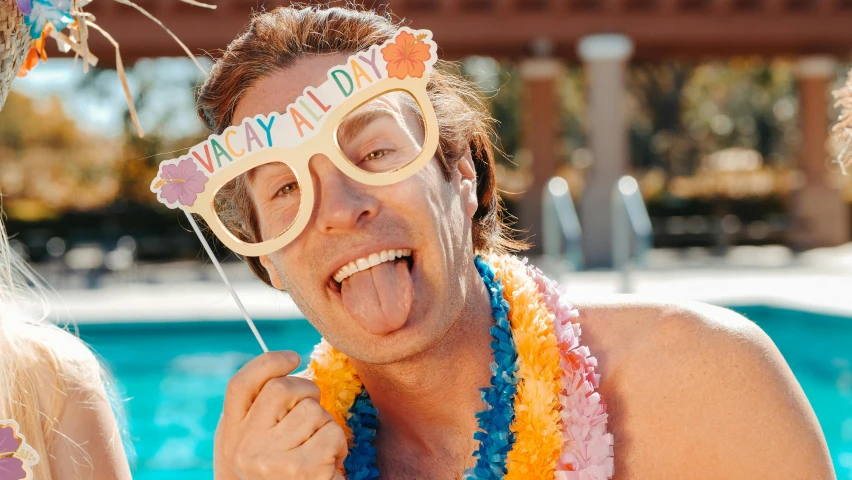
[214,351,347,480]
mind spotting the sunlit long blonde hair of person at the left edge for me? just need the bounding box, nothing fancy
[0,210,123,480]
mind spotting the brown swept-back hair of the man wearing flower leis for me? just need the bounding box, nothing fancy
[197,6,525,284]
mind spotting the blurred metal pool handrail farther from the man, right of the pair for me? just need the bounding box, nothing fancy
[612,175,653,293]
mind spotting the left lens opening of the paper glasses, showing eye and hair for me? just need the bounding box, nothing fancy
[213,162,302,244]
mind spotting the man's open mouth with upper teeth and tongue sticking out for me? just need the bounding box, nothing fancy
[328,248,416,335]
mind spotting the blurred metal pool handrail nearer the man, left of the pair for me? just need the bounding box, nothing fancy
[541,177,583,271]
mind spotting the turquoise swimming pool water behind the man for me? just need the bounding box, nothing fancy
[80,306,852,480]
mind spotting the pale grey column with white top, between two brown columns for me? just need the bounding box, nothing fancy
[577,34,633,268]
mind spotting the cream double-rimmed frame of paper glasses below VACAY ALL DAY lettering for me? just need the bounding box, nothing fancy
[183,74,438,257]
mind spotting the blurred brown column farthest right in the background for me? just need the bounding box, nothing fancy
[790,56,849,249]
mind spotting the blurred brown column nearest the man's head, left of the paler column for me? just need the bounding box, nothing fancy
[517,57,561,253]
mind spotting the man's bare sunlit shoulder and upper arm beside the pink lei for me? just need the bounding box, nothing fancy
[577,296,835,479]
